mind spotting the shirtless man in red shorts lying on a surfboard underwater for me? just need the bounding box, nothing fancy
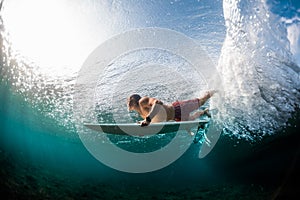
[127,90,217,126]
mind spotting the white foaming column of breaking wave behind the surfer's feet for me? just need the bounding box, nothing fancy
[218,0,300,136]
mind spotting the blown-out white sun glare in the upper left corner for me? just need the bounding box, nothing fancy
[3,0,105,75]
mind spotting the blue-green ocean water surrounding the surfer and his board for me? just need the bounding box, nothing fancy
[0,0,300,199]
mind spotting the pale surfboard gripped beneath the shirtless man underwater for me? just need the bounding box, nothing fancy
[84,120,209,136]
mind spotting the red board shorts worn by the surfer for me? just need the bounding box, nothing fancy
[172,99,199,121]
